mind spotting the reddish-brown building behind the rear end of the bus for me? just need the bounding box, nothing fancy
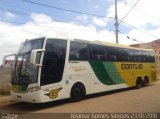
[130,39,160,78]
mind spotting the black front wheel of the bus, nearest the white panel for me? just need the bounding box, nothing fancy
[71,83,86,101]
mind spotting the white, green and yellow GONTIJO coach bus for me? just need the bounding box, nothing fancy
[11,36,157,103]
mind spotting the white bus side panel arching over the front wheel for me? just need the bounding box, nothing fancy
[66,61,93,94]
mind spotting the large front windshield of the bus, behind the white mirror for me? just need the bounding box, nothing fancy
[11,38,44,85]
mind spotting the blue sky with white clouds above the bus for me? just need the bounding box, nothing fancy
[0,0,160,64]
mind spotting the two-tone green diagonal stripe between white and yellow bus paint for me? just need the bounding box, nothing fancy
[89,61,124,85]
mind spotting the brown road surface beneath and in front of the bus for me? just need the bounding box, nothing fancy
[0,81,160,113]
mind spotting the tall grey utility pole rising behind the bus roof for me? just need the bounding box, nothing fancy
[115,0,119,43]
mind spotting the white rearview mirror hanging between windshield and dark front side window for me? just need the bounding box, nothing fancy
[30,49,45,66]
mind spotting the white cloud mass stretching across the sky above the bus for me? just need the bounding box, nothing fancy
[0,0,160,65]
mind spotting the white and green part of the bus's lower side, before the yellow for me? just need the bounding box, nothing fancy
[67,61,128,94]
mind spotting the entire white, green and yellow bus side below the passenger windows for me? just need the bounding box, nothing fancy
[67,61,156,97]
